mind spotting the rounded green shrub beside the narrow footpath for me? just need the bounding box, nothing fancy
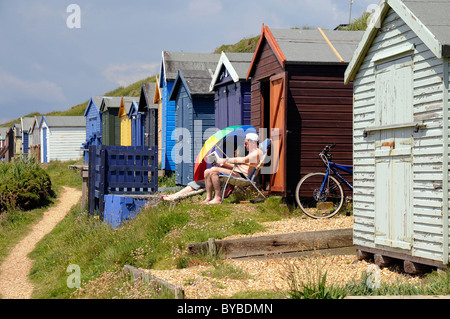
[0,159,53,212]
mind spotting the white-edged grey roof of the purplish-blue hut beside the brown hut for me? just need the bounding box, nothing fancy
[209,52,253,91]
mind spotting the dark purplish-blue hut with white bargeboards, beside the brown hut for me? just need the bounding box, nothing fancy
[209,52,253,129]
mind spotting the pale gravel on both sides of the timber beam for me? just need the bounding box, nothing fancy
[144,216,428,299]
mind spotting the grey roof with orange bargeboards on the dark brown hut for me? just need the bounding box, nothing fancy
[247,25,364,78]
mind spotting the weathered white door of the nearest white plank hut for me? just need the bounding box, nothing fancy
[375,56,414,250]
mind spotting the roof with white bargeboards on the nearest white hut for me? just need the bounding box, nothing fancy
[344,0,450,83]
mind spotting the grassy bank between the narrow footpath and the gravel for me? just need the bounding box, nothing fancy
[27,198,282,298]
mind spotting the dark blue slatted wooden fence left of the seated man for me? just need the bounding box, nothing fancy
[88,145,158,220]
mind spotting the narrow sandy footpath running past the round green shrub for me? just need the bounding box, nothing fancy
[0,187,81,299]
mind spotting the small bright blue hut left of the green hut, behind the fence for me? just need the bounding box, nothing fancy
[83,96,102,163]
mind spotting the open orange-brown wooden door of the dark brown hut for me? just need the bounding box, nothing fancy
[269,72,287,196]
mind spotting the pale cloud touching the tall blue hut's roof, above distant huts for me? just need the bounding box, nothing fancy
[102,63,159,87]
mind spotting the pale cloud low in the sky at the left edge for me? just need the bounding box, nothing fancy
[0,69,67,104]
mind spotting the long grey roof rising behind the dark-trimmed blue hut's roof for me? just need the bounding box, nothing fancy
[160,51,220,86]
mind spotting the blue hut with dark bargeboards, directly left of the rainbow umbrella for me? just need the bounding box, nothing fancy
[169,69,215,185]
